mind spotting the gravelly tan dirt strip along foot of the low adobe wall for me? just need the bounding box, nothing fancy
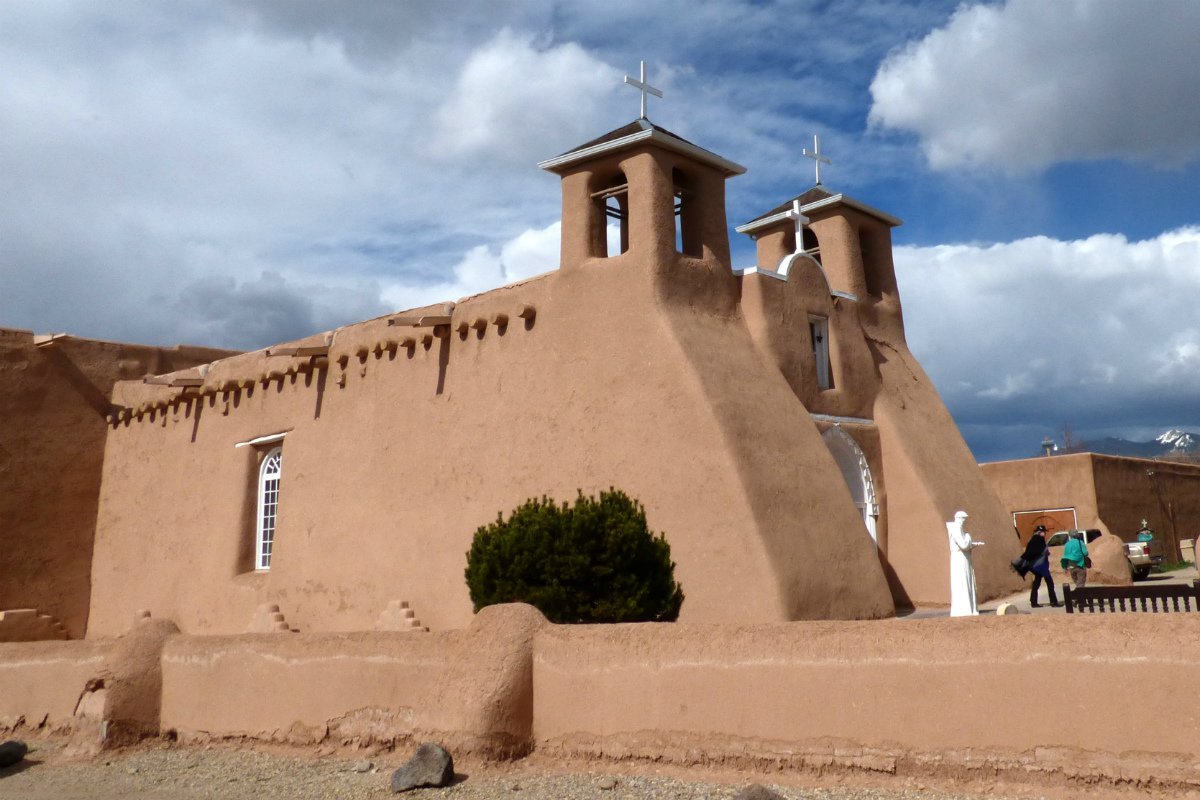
[0,736,1200,800]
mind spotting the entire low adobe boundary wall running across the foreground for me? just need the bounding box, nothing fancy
[0,606,1200,790]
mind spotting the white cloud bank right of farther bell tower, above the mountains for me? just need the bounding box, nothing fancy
[895,227,1200,453]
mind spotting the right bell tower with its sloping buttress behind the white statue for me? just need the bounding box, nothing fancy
[777,209,1020,606]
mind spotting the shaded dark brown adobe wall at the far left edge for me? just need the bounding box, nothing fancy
[0,327,236,637]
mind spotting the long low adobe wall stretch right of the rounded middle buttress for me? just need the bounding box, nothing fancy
[534,614,1200,788]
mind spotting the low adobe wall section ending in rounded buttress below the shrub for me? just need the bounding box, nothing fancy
[162,606,546,756]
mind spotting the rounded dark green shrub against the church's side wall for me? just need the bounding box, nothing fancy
[467,489,683,622]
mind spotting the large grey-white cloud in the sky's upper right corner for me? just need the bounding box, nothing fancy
[870,0,1200,172]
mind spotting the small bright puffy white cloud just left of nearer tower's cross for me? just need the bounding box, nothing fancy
[432,29,620,164]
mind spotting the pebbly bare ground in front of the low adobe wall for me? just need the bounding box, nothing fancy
[0,741,1033,800]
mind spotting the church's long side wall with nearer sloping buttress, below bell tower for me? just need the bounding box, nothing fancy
[91,235,892,636]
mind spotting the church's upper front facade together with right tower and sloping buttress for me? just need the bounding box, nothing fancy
[742,205,1020,606]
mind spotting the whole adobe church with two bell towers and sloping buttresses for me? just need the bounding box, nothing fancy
[8,109,1020,638]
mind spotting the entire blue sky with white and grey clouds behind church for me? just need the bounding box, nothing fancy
[0,0,1200,461]
